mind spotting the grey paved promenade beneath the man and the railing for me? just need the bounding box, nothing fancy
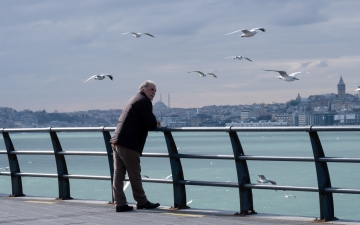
[0,195,360,225]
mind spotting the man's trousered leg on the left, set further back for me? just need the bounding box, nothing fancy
[112,145,127,206]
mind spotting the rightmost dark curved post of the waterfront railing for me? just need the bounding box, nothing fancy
[309,128,337,221]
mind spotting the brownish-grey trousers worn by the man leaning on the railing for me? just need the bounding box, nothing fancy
[112,144,148,206]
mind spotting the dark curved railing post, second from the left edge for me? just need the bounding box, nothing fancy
[50,130,72,200]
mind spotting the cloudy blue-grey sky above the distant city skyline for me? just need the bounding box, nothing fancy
[0,0,360,112]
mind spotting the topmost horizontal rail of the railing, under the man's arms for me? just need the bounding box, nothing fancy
[0,125,360,133]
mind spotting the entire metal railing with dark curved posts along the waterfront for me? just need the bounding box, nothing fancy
[0,126,360,221]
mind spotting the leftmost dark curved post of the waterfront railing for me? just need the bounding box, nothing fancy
[2,132,25,197]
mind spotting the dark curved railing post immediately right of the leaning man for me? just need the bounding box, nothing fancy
[164,131,189,209]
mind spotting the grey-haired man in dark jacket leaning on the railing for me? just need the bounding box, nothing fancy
[110,80,160,212]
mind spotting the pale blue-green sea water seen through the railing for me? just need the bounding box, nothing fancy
[0,132,360,220]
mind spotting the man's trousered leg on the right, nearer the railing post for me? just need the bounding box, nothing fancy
[119,146,148,205]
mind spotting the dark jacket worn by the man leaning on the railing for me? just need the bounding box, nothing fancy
[110,92,157,154]
